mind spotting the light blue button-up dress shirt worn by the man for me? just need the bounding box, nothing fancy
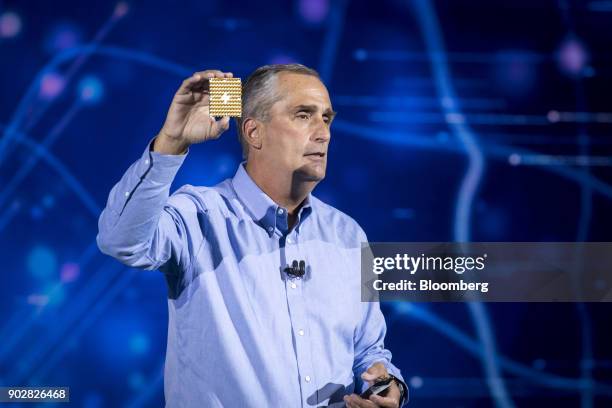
[97,143,403,408]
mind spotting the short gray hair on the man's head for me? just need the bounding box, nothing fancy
[236,64,321,159]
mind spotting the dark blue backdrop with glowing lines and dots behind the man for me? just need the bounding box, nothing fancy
[0,0,612,408]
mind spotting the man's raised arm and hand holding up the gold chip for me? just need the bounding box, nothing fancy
[97,70,232,269]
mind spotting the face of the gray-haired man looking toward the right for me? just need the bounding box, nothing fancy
[260,72,335,181]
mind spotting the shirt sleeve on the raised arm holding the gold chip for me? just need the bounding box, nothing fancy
[96,145,190,270]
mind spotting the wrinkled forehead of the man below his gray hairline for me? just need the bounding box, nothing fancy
[276,72,331,110]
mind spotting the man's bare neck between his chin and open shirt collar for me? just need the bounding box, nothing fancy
[246,161,318,217]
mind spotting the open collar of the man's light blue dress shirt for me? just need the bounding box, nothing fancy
[232,162,312,236]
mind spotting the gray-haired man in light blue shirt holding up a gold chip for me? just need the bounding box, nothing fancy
[98,64,407,408]
